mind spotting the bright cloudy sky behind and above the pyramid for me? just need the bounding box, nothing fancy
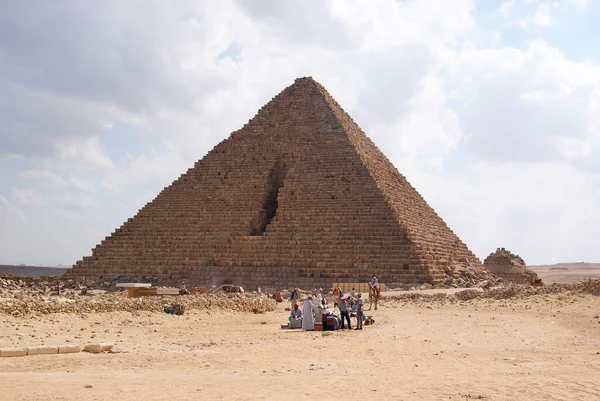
[0,0,600,266]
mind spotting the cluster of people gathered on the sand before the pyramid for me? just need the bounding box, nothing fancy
[290,287,364,330]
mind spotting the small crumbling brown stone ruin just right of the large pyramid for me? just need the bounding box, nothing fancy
[483,248,541,284]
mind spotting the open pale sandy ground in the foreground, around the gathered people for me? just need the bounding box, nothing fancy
[0,294,600,400]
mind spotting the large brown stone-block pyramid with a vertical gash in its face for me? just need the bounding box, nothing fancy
[69,78,481,288]
